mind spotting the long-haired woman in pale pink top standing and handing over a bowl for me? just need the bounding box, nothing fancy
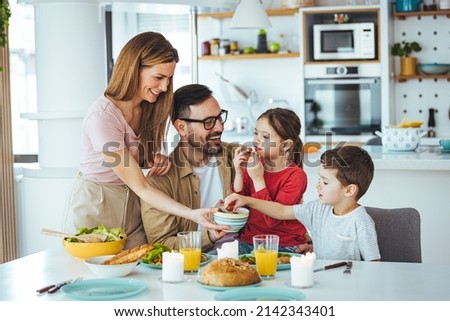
[66,32,226,248]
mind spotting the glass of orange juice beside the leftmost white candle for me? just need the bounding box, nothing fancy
[177,231,202,274]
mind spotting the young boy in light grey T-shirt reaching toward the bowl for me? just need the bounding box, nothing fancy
[225,146,380,261]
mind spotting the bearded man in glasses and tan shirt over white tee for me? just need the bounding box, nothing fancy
[141,84,239,252]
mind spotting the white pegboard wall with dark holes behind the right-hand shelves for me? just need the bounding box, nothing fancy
[394,15,450,137]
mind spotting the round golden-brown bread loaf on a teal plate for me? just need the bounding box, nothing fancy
[200,258,261,286]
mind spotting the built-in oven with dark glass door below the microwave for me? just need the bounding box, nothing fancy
[305,64,381,135]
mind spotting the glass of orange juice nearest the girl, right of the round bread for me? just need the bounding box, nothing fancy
[253,234,279,280]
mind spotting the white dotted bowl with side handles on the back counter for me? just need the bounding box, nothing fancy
[375,127,427,151]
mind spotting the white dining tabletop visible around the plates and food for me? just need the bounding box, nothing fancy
[0,247,450,301]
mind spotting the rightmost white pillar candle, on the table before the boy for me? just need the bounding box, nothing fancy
[291,253,316,287]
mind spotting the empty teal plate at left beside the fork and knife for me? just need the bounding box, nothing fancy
[61,278,147,301]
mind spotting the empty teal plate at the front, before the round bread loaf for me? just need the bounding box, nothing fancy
[214,287,305,301]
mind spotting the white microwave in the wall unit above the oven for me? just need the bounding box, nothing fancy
[313,22,376,60]
